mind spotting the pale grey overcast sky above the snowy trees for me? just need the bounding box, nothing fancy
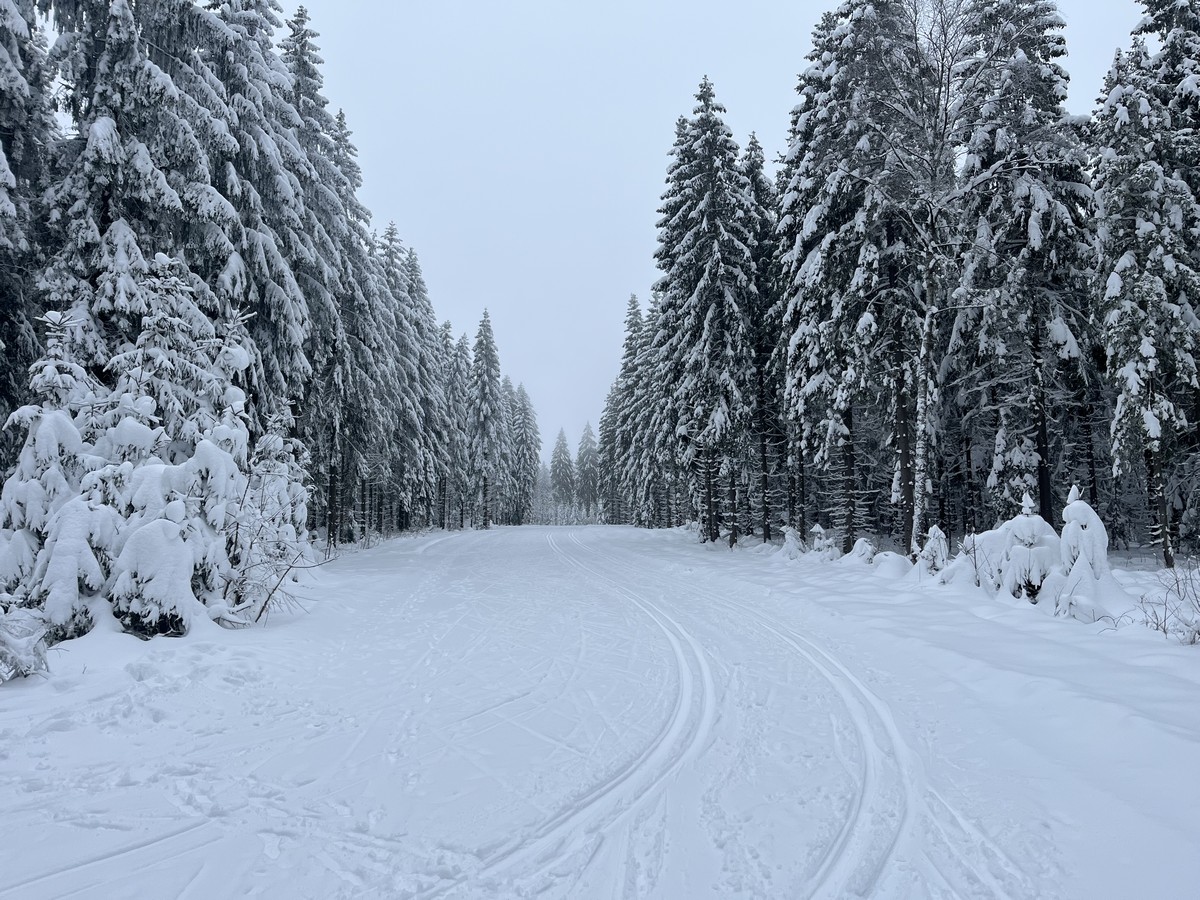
[290,0,1141,458]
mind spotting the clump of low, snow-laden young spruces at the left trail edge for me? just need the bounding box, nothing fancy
[0,309,308,682]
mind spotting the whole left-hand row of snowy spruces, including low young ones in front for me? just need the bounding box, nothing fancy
[0,0,541,640]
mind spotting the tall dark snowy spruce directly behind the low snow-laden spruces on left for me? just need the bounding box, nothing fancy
[41,0,218,374]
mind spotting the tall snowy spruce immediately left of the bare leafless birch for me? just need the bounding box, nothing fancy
[779,0,918,552]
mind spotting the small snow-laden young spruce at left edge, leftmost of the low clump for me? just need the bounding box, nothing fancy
[0,312,113,643]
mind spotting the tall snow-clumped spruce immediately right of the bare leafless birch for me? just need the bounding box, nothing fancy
[950,0,1092,522]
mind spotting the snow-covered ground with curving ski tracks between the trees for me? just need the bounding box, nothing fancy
[0,527,1200,900]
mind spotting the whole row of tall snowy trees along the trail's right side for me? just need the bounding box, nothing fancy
[600,0,1200,565]
